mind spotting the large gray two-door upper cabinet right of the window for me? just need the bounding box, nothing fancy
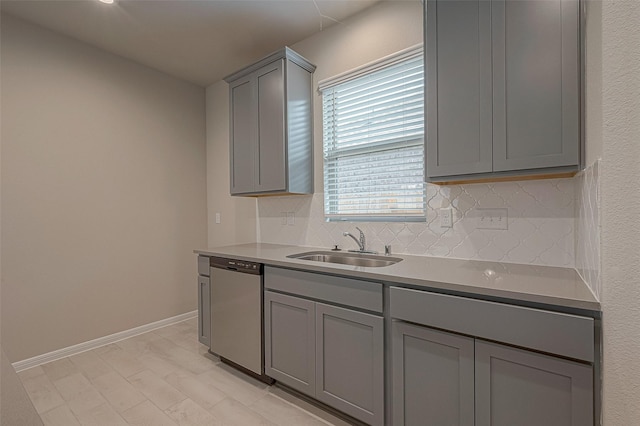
[425,0,581,182]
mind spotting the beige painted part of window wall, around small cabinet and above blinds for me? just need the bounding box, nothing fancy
[202,0,422,247]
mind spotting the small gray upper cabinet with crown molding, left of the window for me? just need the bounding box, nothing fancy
[225,48,315,196]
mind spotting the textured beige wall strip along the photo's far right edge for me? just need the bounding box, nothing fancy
[599,0,640,426]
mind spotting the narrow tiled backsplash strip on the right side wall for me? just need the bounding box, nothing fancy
[576,161,602,300]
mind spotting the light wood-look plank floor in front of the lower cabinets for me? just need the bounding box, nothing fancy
[19,318,347,426]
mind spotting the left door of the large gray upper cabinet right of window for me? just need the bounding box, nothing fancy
[425,0,492,177]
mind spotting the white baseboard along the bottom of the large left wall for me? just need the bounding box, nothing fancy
[11,311,198,372]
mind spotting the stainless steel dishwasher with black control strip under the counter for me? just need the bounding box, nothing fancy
[210,257,271,382]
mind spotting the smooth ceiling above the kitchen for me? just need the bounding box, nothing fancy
[0,0,382,86]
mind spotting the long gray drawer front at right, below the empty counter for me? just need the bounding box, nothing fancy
[390,287,594,362]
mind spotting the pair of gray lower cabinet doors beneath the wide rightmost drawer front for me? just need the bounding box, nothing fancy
[393,321,594,426]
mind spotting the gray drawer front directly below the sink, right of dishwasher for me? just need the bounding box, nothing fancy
[264,266,382,312]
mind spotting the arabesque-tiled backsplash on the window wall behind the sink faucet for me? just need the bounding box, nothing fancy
[258,179,576,267]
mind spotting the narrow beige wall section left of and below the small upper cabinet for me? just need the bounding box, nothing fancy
[207,81,256,247]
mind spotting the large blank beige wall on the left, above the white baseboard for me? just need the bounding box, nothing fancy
[1,16,206,362]
